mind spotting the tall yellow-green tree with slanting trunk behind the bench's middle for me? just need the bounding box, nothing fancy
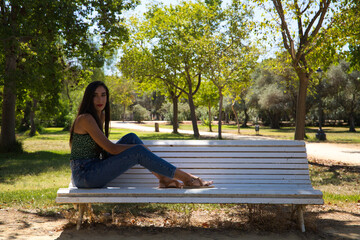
[147,2,219,138]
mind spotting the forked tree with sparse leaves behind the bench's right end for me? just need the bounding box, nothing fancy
[254,0,333,140]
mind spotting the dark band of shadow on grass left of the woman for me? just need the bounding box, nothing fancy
[0,151,70,182]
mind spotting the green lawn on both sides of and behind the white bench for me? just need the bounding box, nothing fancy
[0,126,360,211]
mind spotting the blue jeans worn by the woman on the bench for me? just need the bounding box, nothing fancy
[70,133,176,188]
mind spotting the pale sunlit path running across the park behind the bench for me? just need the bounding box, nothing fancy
[111,121,360,166]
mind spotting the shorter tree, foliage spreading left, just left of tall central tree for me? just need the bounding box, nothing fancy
[118,29,182,133]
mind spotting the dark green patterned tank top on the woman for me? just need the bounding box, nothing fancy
[70,133,100,160]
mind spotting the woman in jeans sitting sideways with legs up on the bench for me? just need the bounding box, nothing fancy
[70,81,212,188]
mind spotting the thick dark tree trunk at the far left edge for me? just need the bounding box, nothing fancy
[0,51,16,151]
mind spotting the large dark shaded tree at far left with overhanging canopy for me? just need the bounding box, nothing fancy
[0,0,136,150]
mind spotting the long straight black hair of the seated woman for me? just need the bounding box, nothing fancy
[70,81,110,146]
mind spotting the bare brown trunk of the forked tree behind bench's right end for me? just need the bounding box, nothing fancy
[295,73,309,140]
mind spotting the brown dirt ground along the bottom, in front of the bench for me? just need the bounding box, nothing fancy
[0,204,360,240]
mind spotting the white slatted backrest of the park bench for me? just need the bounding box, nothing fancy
[107,140,312,189]
